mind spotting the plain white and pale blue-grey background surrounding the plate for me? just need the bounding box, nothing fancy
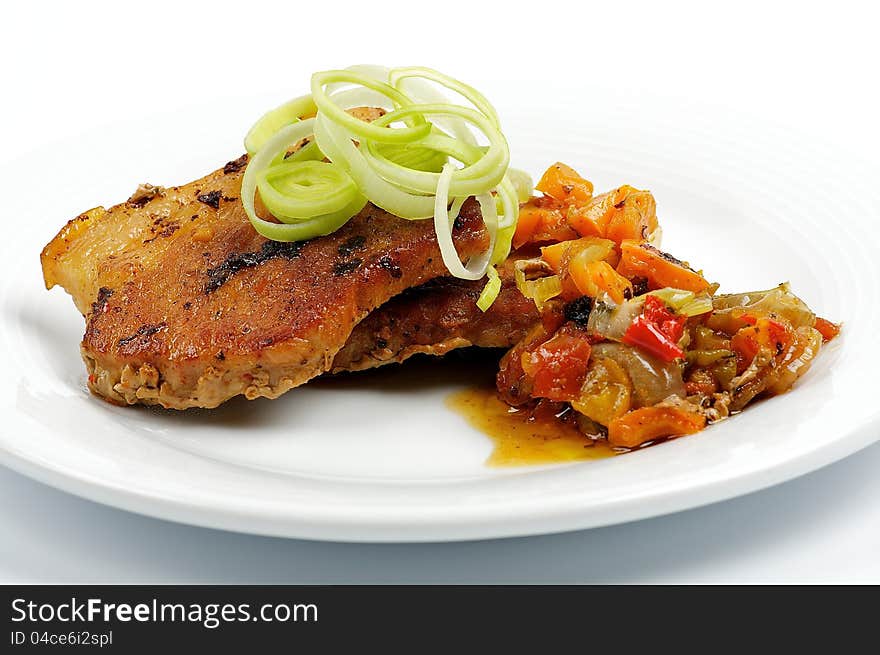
[0,1,880,583]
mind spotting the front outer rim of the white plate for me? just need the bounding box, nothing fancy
[0,410,880,543]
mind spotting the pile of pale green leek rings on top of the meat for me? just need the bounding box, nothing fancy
[242,66,528,311]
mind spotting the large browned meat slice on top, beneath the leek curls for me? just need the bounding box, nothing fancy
[41,158,487,409]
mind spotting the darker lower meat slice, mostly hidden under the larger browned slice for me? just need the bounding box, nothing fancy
[331,260,539,373]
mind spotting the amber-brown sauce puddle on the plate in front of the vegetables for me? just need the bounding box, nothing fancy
[446,387,617,466]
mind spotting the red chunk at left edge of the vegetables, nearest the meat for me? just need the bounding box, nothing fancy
[522,332,592,401]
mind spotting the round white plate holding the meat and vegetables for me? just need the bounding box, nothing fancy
[0,88,880,541]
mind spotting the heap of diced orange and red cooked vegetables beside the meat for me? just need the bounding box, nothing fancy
[497,164,839,449]
